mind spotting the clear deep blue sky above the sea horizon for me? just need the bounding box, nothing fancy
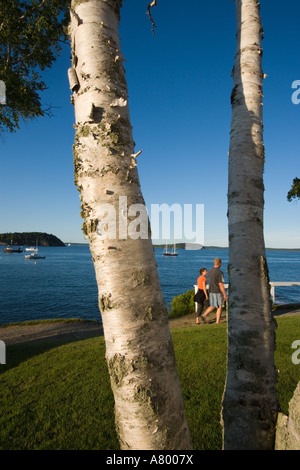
[0,0,300,248]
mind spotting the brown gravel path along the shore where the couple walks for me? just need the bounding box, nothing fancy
[0,304,300,345]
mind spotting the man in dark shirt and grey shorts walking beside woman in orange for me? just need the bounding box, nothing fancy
[200,258,227,323]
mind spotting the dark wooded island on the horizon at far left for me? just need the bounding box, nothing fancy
[0,232,65,246]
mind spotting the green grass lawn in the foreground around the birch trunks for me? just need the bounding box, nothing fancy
[0,317,300,450]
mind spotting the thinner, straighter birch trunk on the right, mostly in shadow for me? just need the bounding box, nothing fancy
[222,0,277,450]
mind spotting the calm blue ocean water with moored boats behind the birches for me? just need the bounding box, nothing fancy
[0,245,300,323]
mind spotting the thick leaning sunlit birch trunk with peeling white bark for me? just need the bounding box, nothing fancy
[69,0,191,450]
